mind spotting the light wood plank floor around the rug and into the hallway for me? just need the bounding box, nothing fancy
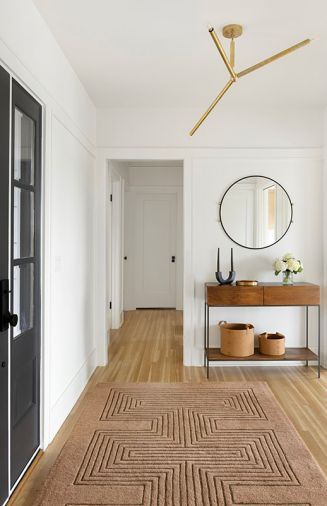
[9,310,327,506]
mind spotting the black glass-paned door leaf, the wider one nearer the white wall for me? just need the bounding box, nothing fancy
[10,80,42,486]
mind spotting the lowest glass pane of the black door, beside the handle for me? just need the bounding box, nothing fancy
[13,263,34,337]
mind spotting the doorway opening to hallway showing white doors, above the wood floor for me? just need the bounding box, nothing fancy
[107,160,184,350]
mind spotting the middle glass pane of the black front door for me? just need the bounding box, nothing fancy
[14,187,34,259]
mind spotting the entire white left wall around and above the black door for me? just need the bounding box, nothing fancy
[0,0,96,447]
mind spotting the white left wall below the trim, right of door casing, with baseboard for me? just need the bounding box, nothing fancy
[50,119,96,434]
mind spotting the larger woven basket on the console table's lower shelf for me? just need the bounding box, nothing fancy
[219,321,254,358]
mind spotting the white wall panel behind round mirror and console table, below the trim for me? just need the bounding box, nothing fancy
[192,154,323,362]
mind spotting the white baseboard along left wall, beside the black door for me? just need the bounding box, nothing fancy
[50,348,97,442]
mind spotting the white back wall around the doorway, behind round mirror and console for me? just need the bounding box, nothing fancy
[97,107,327,365]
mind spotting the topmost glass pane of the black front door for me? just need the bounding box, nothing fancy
[14,108,35,185]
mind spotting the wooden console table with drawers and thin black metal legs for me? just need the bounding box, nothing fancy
[204,283,320,378]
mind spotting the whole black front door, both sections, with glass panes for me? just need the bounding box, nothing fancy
[0,67,42,505]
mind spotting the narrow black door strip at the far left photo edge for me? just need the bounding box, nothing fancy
[0,67,10,504]
